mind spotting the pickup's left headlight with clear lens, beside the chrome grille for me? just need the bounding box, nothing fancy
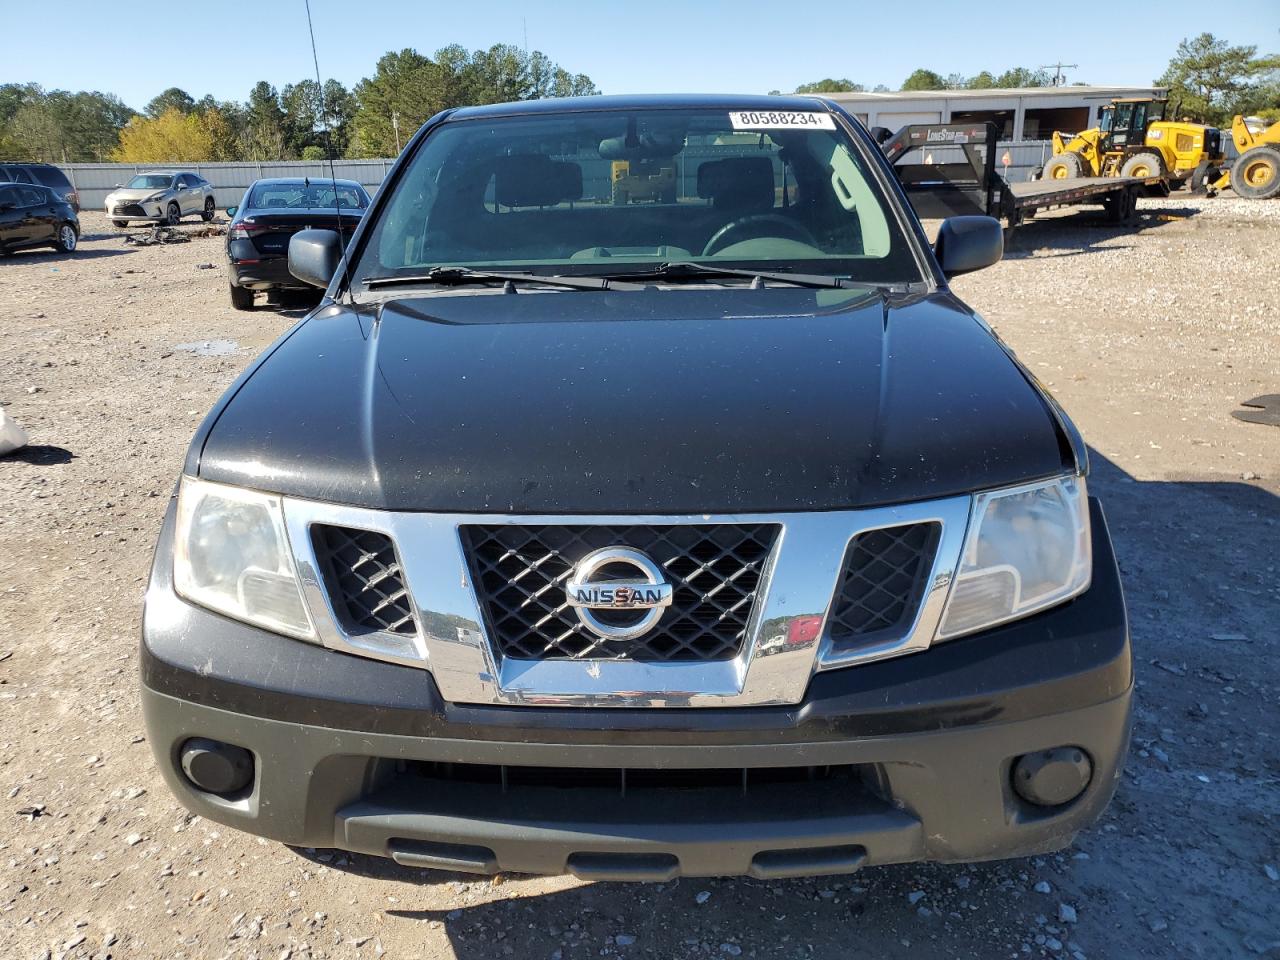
[173,477,315,640]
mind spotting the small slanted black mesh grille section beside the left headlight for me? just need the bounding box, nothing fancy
[311,524,417,636]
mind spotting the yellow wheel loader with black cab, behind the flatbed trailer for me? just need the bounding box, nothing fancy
[1041,97,1225,188]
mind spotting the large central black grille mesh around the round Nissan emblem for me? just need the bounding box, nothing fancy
[462,524,778,660]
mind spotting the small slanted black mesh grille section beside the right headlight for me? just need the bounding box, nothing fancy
[828,522,941,649]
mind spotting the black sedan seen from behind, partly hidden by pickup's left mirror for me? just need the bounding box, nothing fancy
[227,178,370,310]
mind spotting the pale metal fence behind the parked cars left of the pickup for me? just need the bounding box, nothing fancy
[59,160,396,210]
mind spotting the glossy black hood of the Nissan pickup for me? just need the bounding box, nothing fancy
[197,287,1070,513]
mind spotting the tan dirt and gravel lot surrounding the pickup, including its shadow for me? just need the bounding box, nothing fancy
[0,198,1280,960]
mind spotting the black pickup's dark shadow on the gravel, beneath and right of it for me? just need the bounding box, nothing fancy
[294,449,1280,960]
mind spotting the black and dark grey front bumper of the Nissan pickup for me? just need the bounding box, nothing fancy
[142,502,1133,879]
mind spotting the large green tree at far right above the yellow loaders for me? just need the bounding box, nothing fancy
[1156,33,1280,127]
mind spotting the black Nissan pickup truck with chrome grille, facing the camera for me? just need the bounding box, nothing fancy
[141,97,1133,879]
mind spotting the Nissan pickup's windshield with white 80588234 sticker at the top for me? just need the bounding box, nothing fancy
[353,109,922,283]
